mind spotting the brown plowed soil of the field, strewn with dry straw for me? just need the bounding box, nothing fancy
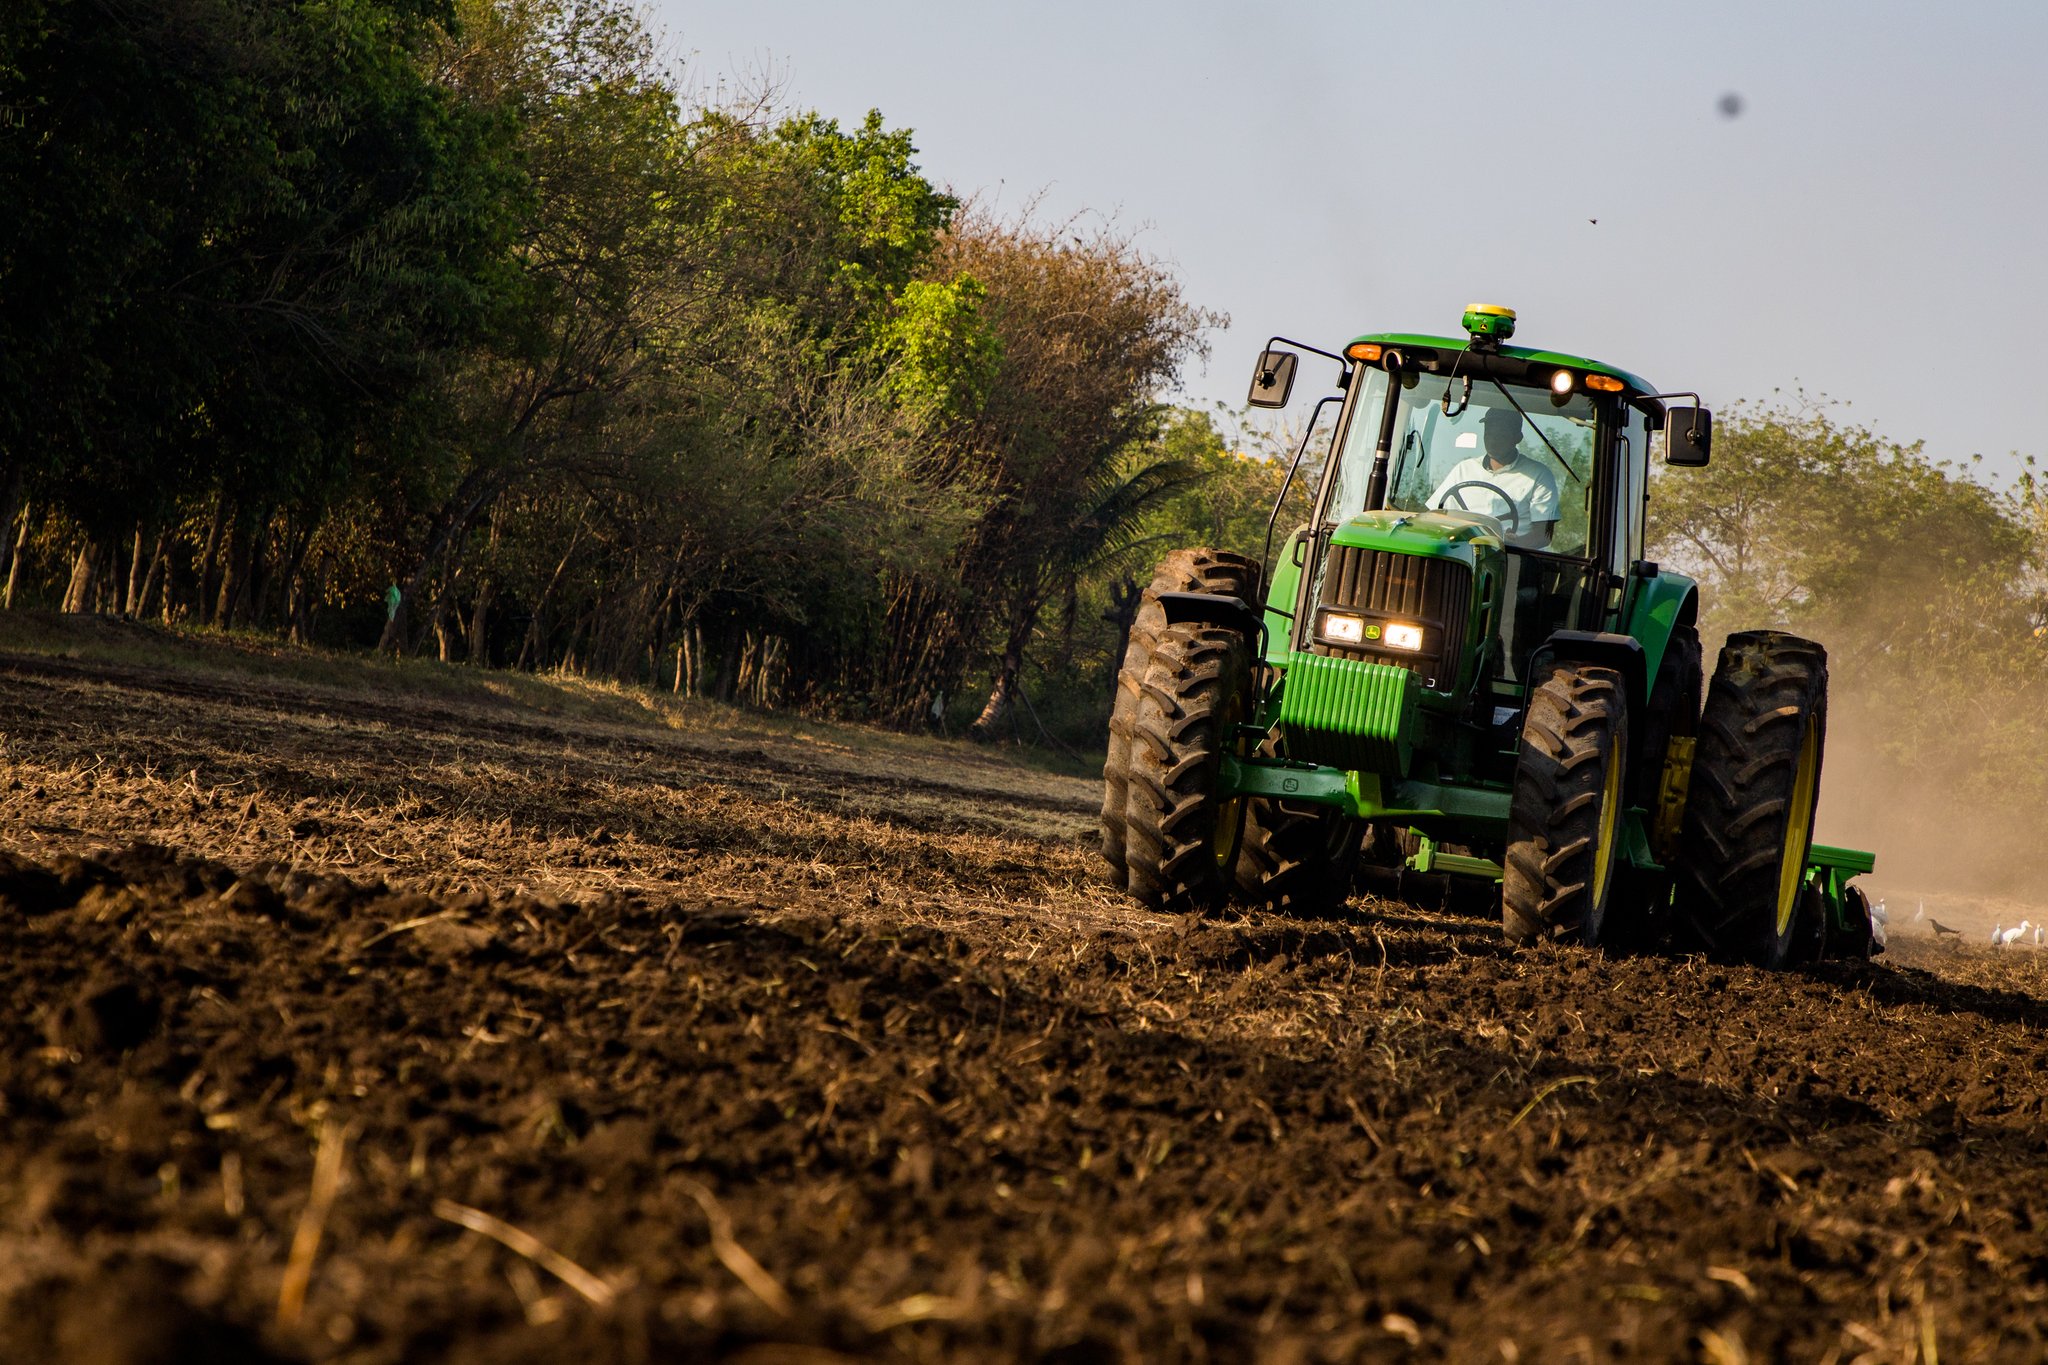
[0,626,2048,1365]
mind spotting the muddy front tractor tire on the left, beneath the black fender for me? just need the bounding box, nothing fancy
[1124,624,1253,913]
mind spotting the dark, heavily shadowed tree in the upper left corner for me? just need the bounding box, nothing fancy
[0,0,512,614]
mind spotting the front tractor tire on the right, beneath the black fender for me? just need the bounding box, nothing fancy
[1501,663,1628,948]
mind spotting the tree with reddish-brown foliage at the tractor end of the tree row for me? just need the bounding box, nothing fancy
[879,213,1217,733]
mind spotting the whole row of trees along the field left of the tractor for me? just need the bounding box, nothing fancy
[0,0,1270,737]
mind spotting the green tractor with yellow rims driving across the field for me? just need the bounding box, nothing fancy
[1102,305,1882,968]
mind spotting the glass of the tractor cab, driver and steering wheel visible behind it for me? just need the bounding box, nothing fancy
[1327,370,1595,557]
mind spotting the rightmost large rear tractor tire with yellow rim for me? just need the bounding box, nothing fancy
[1677,630,1827,968]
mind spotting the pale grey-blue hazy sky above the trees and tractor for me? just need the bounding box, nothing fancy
[651,0,2048,480]
